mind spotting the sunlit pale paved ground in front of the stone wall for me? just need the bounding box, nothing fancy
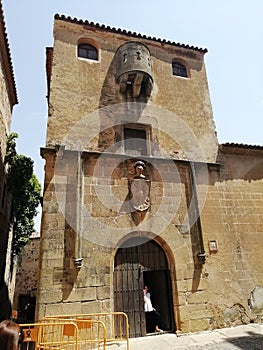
[111,324,263,350]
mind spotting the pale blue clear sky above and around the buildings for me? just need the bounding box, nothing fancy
[2,0,263,230]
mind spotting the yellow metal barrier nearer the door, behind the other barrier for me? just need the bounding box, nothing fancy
[42,312,129,350]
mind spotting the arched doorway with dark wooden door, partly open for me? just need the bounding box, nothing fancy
[114,236,175,337]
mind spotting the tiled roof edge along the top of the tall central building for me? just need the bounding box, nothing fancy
[54,14,207,53]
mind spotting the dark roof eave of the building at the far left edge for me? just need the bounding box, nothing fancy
[0,0,18,105]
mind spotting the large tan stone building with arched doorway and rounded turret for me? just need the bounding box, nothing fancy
[36,15,263,337]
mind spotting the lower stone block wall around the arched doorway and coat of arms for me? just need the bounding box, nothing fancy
[39,144,263,332]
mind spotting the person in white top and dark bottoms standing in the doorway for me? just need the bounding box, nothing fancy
[143,286,163,333]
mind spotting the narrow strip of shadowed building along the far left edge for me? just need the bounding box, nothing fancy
[0,1,18,318]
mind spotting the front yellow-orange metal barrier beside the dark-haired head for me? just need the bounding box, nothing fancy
[21,319,106,350]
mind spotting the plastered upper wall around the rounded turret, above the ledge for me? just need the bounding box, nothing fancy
[46,20,217,161]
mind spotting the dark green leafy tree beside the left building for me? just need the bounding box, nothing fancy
[5,132,41,255]
